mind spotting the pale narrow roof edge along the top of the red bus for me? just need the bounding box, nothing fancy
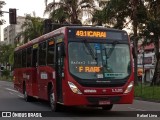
[15,25,126,51]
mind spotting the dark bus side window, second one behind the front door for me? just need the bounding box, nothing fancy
[38,42,46,65]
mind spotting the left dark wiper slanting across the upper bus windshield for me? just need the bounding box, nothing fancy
[83,40,98,62]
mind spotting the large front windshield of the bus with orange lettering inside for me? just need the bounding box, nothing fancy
[68,42,131,79]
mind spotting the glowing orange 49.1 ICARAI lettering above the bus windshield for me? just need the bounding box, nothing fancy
[76,30,107,38]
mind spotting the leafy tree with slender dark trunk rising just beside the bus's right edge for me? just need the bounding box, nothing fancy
[93,0,152,82]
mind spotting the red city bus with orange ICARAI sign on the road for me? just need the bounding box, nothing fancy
[14,26,134,111]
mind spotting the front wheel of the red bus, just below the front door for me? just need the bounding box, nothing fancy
[49,89,58,112]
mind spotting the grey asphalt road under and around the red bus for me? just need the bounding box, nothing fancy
[0,81,160,120]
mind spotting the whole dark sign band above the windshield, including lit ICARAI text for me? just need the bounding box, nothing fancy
[68,28,128,41]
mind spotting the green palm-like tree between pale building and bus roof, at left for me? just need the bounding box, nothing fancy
[16,13,43,43]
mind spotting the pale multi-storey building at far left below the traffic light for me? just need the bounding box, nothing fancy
[3,16,25,44]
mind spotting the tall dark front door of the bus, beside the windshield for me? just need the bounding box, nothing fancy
[56,43,64,103]
